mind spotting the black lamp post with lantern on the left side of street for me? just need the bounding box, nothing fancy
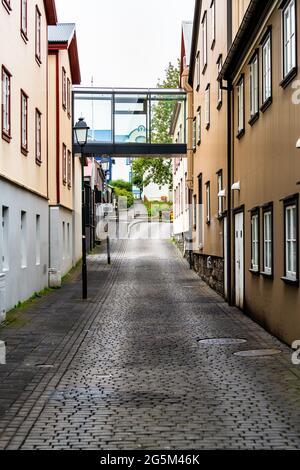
[74,117,90,300]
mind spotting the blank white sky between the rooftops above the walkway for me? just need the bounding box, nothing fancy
[56,0,194,88]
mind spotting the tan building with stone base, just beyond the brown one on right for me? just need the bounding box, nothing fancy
[188,0,231,294]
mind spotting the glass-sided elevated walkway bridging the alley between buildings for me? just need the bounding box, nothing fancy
[73,87,187,158]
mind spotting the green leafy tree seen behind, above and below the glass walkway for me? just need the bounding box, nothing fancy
[133,61,180,189]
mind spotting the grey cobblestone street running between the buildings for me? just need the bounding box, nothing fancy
[0,240,300,450]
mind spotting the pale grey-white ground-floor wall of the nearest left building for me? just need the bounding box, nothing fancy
[0,179,49,310]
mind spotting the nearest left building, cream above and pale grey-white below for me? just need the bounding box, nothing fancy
[0,0,57,309]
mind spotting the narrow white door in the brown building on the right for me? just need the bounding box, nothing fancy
[235,212,244,309]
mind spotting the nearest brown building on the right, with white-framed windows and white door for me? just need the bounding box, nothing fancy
[221,0,300,344]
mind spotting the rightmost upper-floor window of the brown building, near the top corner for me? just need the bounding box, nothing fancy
[283,0,296,78]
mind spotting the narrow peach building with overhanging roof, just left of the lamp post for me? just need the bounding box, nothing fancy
[48,24,81,286]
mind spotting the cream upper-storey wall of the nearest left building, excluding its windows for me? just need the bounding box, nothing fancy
[0,0,48,198]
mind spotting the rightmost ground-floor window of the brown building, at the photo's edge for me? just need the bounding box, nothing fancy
[285,199,298,281]
